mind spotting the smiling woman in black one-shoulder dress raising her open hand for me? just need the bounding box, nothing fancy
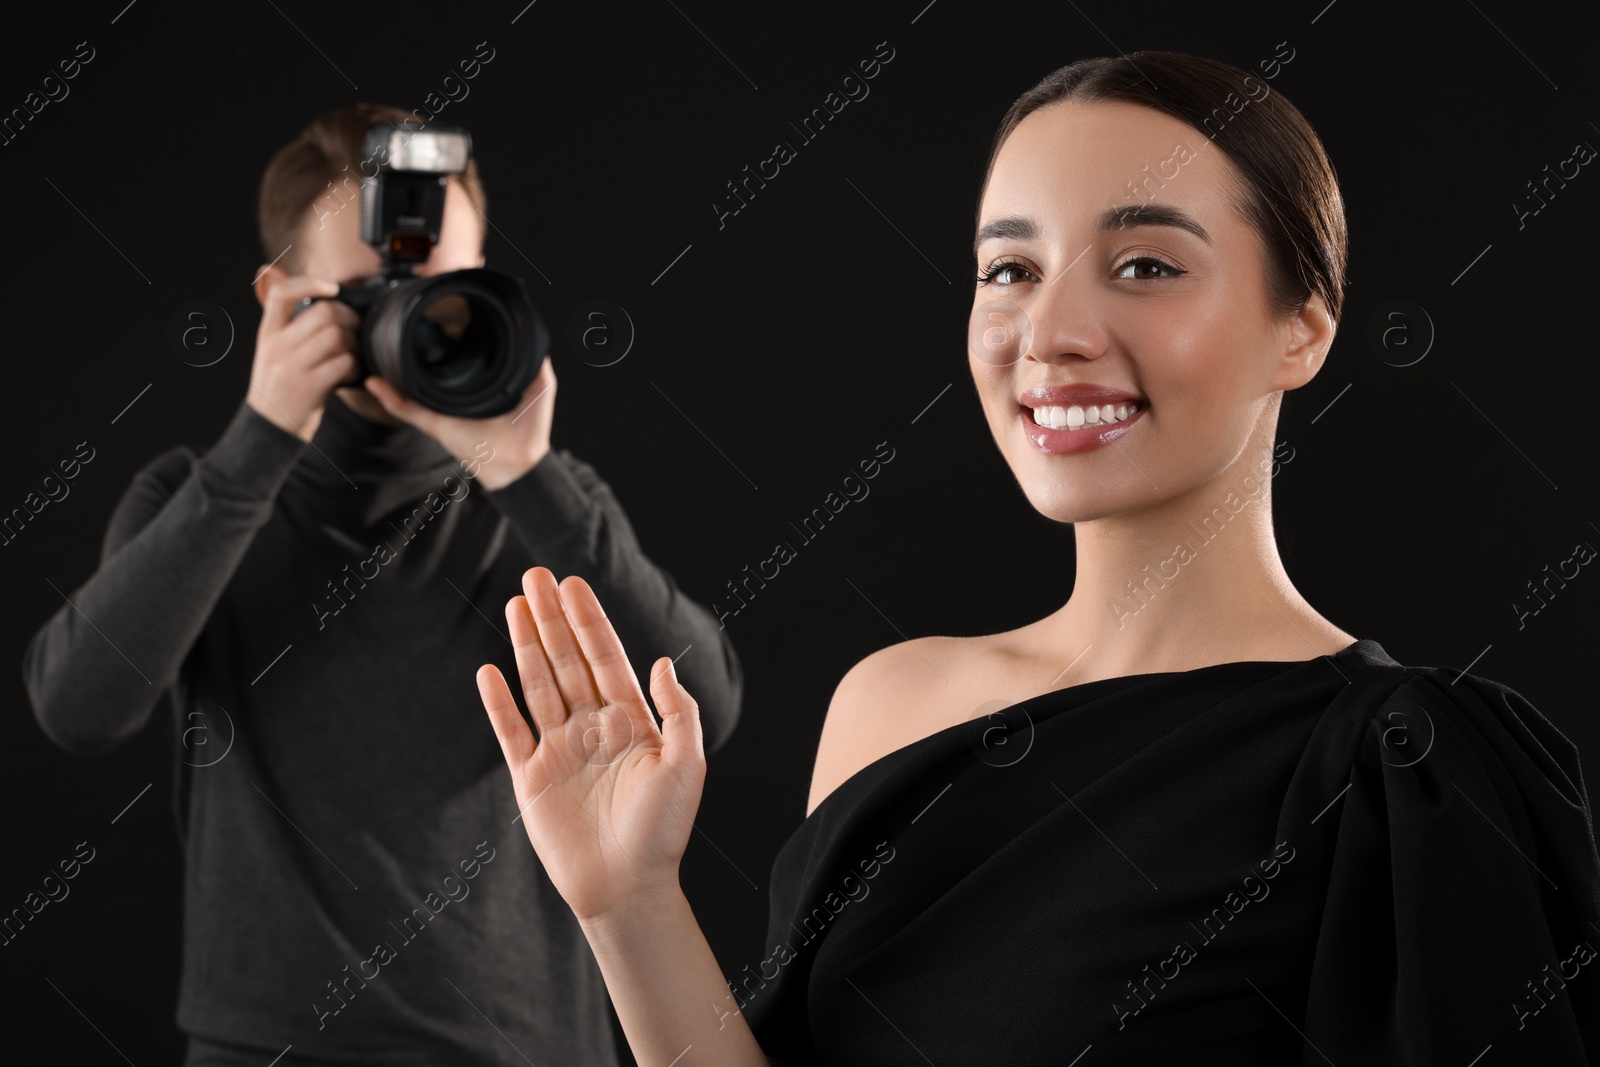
[478,53,1600,1067]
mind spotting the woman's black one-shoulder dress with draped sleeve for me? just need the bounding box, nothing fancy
[731,640,1600,1067]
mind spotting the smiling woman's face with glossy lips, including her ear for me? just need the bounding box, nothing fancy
[968,102,1333,522]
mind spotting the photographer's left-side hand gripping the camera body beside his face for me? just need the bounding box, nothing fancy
[245,275,360,440]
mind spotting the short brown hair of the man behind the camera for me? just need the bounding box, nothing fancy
[256,102,488,274]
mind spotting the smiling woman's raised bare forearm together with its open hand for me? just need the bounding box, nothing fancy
[477,566,768,1067]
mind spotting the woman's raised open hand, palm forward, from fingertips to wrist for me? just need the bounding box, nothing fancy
[477,566,706,918]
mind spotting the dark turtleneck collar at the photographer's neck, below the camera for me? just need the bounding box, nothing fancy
[291,394,461,528]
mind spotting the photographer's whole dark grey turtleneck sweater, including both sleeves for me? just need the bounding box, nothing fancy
[24,397,742,1067]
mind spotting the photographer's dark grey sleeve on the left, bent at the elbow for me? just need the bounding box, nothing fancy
[22,403,306,755]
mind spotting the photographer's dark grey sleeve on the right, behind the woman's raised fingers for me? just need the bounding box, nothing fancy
[488,448,744,752]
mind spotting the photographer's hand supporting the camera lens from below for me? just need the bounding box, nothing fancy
[365,355,555,490]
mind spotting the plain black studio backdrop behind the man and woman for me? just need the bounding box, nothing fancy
[0,0,1600,1064]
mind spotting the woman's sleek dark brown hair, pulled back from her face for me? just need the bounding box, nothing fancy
[978,50,1349,322]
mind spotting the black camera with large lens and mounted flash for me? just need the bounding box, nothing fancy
[294,122,550,419]
